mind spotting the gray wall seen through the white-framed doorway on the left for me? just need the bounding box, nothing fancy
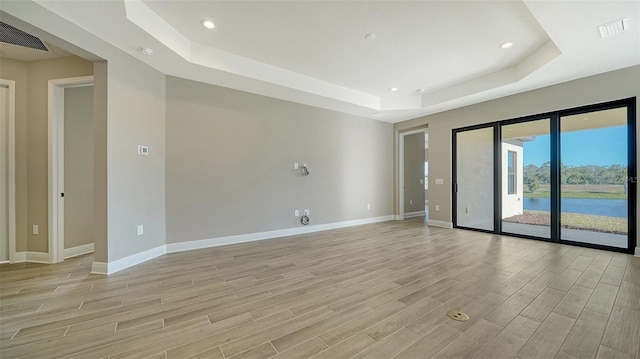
[64,86,93,248]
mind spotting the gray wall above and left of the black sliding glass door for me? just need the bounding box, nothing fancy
[394,66,640,232]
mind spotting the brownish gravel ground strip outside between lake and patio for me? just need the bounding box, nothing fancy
[504,211,627,234]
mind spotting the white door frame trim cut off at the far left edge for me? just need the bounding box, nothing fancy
[0,79,16,263]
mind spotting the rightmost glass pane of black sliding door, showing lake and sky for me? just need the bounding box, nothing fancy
[560,107,629,248]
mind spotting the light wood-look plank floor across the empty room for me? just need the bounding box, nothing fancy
[0,218,640,359]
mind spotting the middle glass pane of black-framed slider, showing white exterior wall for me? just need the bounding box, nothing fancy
[500,119,551,238]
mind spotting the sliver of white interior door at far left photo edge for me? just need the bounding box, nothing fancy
[0,84,9,262]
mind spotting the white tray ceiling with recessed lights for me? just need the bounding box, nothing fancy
[0,0,640,122]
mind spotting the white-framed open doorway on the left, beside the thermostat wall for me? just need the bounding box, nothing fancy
[49,76,93,263]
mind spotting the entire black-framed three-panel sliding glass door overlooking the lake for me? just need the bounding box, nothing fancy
[453,98,637,253]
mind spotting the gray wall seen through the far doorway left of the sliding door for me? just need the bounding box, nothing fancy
[404,132,425,213]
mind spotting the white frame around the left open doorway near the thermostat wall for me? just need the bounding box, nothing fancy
[48,76,93,263]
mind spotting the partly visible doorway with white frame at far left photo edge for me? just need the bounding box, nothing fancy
[0,79,16,263]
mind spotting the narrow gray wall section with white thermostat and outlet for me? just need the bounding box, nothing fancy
[106,54,166,262]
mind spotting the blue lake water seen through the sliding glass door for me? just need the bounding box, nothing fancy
[524,197,627,218]
